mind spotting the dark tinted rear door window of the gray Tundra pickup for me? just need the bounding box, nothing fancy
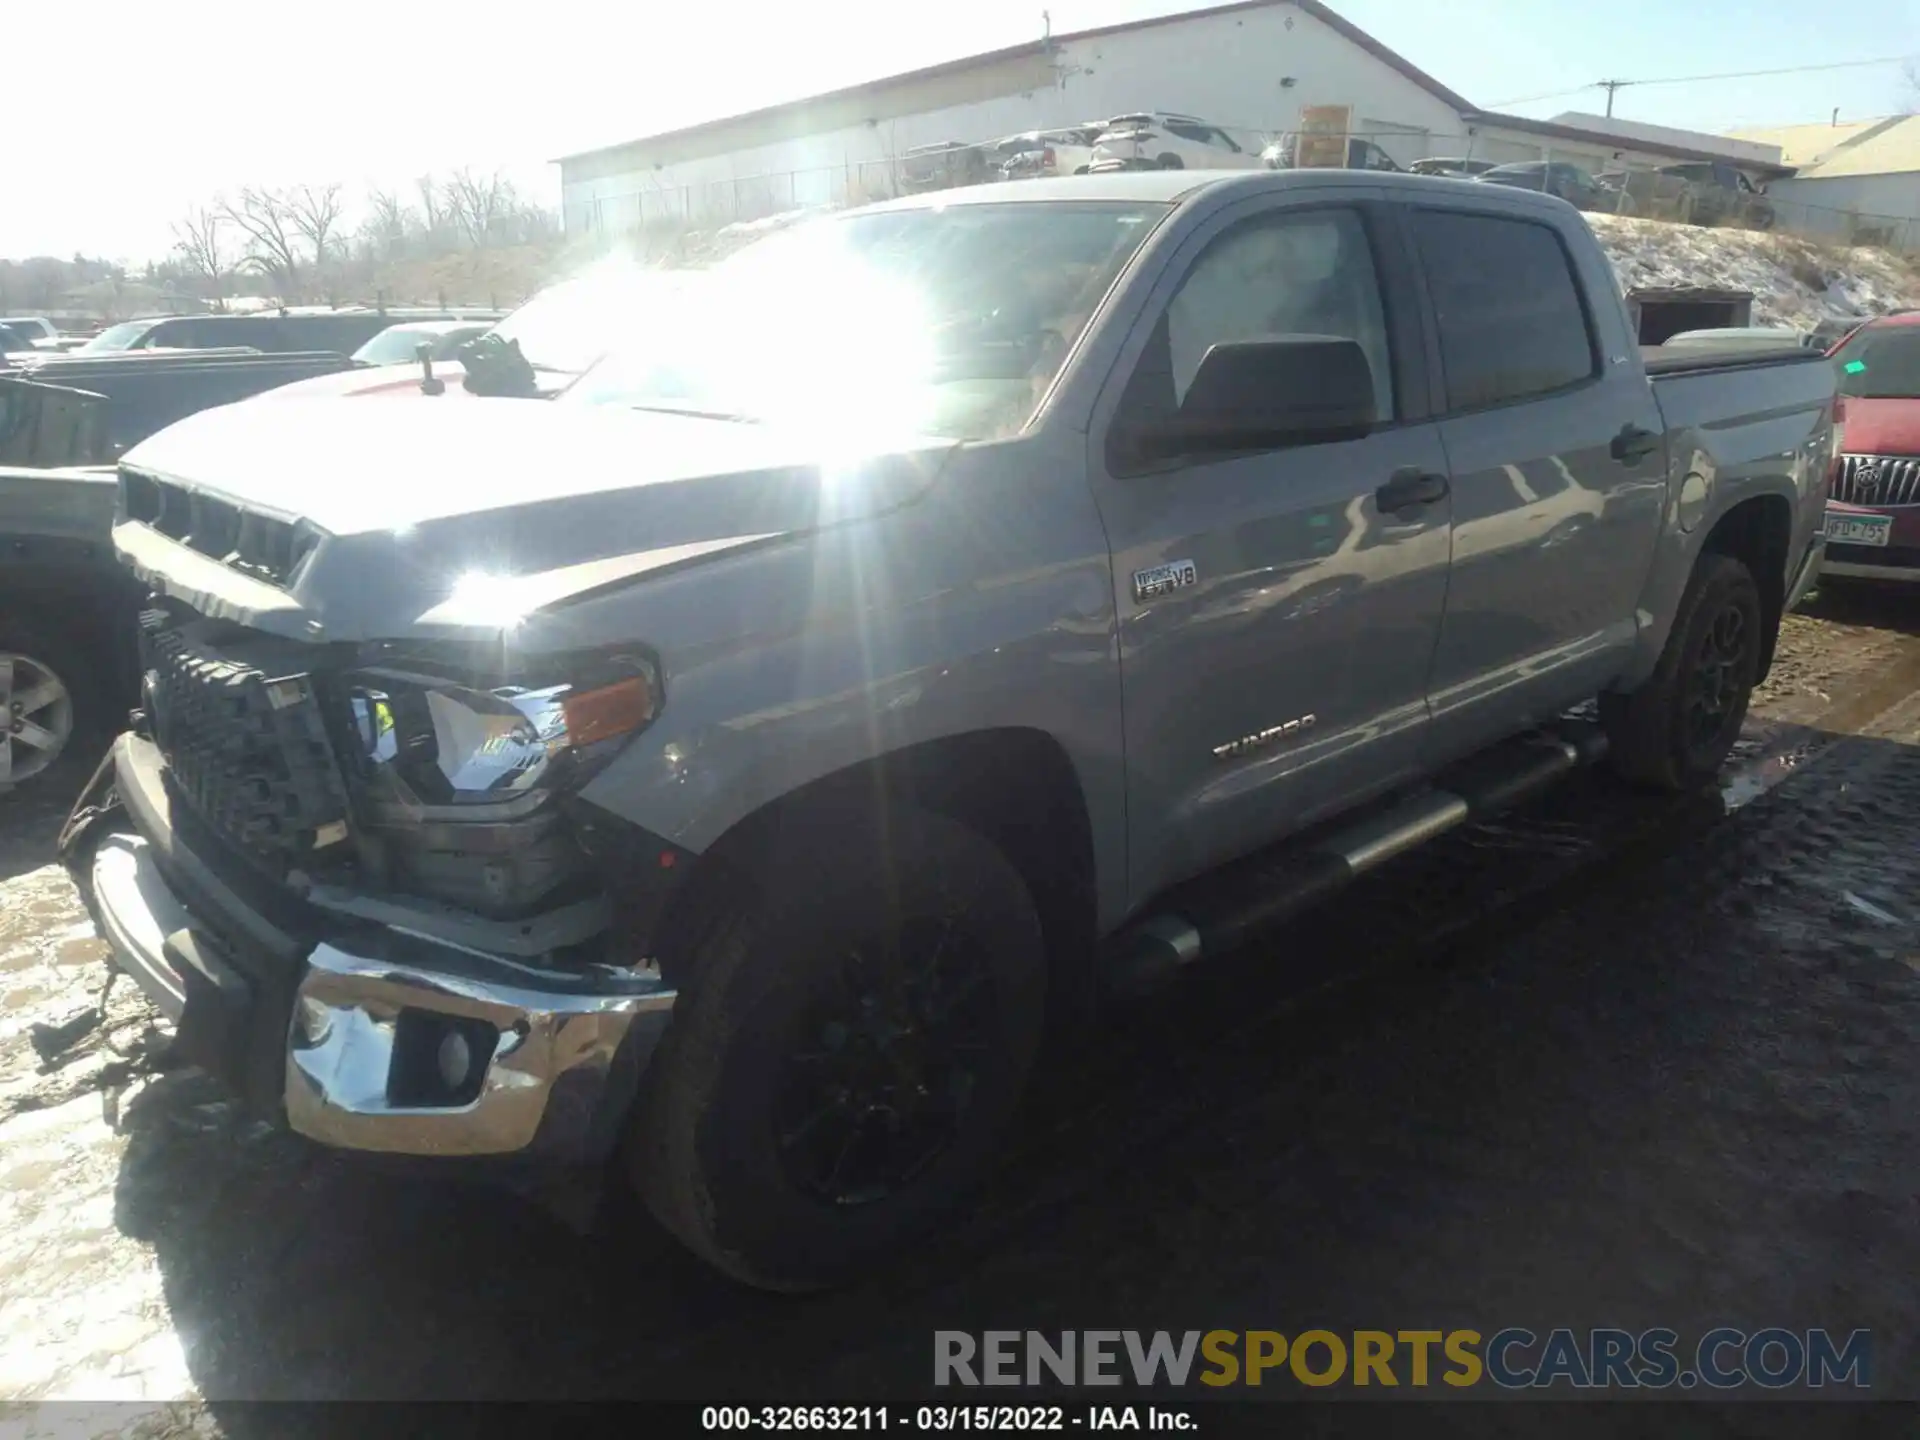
[1411,209,1599,411]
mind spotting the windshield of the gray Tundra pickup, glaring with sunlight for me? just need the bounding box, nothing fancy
[566,204,1165,440]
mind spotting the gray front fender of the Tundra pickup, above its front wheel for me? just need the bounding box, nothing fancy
[549,438,1125,929]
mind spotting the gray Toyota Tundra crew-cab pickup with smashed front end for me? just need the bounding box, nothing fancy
[61,171,1834,1288]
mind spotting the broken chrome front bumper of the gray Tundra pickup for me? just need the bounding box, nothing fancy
[74,737,674,1164]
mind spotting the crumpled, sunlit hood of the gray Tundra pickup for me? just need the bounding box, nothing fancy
[115,399,956,639]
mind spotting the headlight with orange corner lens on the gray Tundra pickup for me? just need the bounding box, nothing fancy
[336,659,660,820]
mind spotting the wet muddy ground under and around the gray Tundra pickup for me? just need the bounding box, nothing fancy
[0,599,1920,1434]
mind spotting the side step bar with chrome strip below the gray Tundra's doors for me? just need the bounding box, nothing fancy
[1108,724,1607,993]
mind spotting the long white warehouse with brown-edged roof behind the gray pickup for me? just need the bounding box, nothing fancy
[559,0,1778,232]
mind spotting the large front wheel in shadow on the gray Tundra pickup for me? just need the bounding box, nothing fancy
[628,810,1046,1290]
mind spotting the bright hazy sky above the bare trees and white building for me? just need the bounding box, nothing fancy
[0,0,1920,259]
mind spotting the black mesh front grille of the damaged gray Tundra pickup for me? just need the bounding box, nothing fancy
[140,611,348,874]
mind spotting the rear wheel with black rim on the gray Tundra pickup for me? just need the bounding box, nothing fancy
[1599,555,1763,791]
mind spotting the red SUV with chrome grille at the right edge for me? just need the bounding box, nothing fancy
[1820,313,1920,582]
